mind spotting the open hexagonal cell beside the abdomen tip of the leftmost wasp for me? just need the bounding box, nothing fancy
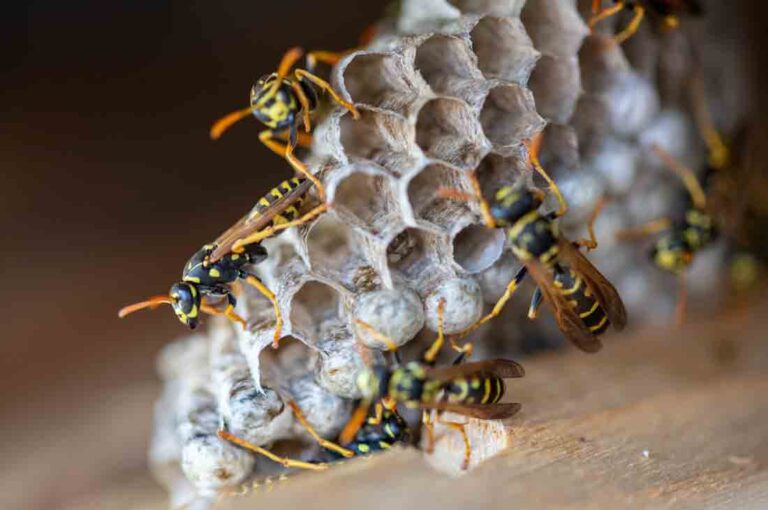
[333,172,400,235]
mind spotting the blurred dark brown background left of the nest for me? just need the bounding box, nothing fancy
[0,0,383,509]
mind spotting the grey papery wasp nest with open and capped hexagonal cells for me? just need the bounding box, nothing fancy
[152,0,744,502]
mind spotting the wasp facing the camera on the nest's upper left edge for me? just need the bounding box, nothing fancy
[210,48,360,201]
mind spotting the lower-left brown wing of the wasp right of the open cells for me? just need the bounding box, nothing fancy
[526,260,603,352]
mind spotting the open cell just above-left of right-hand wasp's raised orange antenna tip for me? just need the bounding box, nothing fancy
[480,85,544,151]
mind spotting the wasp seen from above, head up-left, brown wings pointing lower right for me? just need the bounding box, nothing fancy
[442,136,627,352]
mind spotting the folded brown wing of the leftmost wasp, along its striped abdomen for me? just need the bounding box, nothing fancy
[210,180,312,262]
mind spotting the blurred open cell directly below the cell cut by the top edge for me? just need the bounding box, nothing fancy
[529,55,581,124]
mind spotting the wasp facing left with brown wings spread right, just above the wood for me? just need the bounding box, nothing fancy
[339,301,525,469]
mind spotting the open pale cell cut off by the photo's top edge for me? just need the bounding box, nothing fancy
[520,0,589,57]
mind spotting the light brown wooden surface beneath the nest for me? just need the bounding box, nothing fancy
[217,294,768,510]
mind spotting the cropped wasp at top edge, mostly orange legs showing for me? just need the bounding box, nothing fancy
[589,0,704,44]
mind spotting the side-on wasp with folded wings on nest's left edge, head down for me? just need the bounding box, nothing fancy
[118,178,325,347]
